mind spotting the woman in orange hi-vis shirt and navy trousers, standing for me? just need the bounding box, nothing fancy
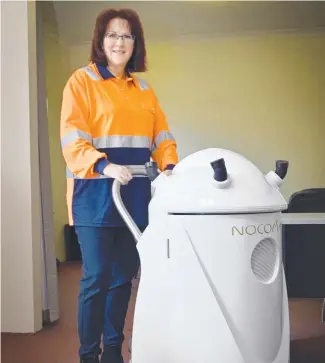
[61,5,178,363]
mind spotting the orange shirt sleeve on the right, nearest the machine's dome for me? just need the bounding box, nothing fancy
[151,97,178,171]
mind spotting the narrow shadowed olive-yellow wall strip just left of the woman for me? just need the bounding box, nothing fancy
[37,1,69,261]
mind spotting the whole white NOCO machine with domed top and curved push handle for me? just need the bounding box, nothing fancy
[113,148,290,363]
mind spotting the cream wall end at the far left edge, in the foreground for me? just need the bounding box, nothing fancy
[1,1,42,333]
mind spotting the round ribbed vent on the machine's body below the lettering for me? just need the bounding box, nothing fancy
[251,238,278,283]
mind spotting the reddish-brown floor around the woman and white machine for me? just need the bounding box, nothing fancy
[1,263,325,363]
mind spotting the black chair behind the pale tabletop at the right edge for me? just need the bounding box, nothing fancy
[283,188,325,298]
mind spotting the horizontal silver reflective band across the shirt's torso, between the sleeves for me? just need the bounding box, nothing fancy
[93,135,151,149]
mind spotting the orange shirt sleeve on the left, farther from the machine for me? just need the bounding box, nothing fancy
[60,73,109,178]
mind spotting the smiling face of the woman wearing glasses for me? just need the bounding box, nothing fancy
[103,18,134,68]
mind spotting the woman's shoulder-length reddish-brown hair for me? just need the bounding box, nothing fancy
[90,9,147,72]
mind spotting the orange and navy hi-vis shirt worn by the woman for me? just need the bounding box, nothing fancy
[60,63,178,227]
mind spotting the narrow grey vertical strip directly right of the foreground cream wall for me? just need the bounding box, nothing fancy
[36,4,59,324]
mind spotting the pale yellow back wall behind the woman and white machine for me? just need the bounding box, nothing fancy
[50,33,325,258]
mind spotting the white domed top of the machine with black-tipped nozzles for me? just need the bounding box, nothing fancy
[154,148,288,214]
